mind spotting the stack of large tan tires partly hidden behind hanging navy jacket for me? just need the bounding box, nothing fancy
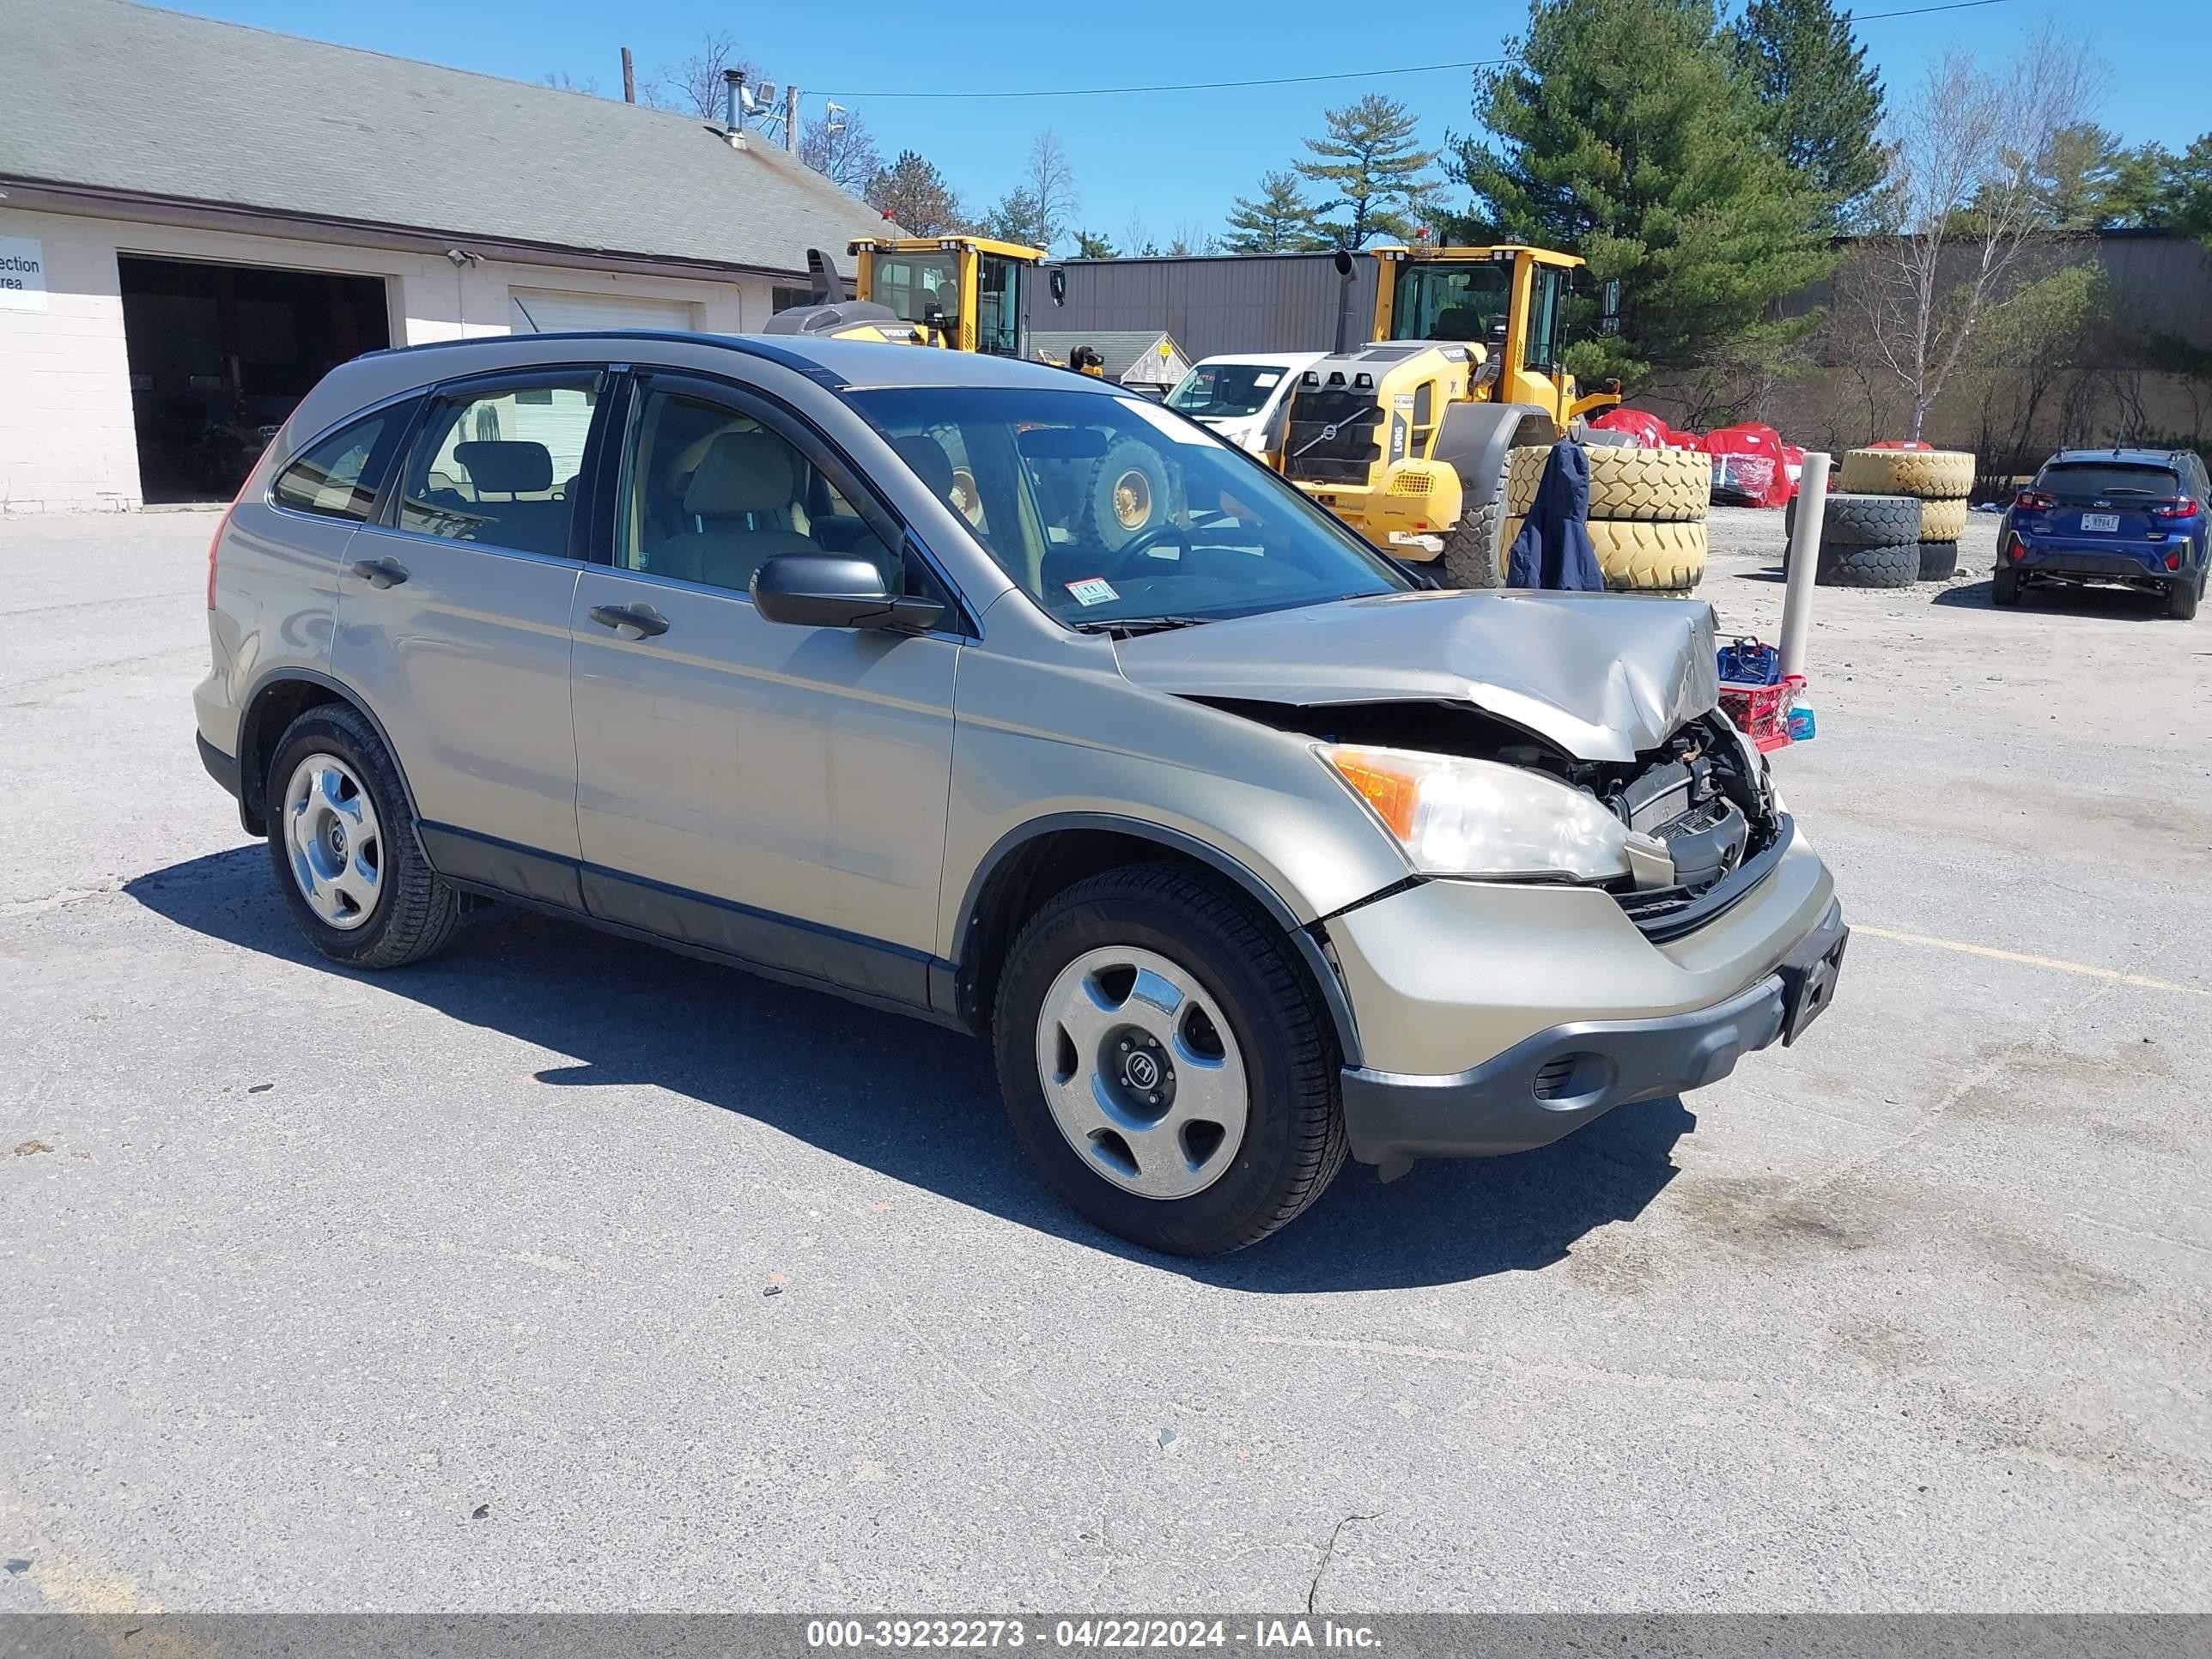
[1498,442,1712,592]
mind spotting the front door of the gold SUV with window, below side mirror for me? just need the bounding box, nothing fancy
[571,374,960,1005]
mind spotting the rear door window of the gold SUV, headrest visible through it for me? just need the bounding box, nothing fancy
[398,372,599,557]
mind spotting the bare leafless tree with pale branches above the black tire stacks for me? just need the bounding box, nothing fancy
[1854,24,2101,438]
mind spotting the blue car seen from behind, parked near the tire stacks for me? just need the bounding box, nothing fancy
[1990,449,2212,622]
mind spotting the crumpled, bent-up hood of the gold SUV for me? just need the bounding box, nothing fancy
[1119,591,1719,761]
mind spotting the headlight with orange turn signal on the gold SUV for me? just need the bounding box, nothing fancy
[1318,744,1666,880]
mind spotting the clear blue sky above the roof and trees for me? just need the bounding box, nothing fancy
[167,0,2212,243]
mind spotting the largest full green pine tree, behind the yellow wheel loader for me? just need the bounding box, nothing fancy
[1458,0,1834,380]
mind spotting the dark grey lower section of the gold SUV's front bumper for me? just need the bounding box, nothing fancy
[1343,900,1851,1175]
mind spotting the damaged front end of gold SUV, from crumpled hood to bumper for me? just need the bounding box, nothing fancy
[1121,592,1847,1175]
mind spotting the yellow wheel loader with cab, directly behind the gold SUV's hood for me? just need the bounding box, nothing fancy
[1274,246,1621,588]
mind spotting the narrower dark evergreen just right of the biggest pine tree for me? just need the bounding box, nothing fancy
[1728,0,1882,228]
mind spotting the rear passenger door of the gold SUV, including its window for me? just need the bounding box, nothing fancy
[331,368,606,907]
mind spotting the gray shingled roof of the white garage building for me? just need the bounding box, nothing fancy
[0,0,884,272]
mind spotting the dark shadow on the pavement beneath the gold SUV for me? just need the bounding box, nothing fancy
[124,842,1697,1294]
